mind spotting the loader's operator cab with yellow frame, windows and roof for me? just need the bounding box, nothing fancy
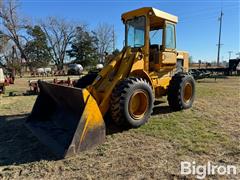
[122,8,178,71]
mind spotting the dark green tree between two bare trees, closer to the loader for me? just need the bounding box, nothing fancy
[67,27,98,66]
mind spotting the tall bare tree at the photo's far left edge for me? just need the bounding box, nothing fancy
[0,0,28,61]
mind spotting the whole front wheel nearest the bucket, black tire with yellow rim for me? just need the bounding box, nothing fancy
[111,77,154,128]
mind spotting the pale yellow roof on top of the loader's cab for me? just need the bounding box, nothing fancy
[122,7,178,23]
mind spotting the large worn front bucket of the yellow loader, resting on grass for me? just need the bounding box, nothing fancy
[26,81,106,158]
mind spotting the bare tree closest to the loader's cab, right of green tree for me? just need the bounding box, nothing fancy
[95,23,115,62]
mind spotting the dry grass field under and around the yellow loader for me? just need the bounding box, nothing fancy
[0,77,240,179]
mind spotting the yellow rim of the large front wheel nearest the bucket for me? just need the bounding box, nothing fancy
[129,90,148,120]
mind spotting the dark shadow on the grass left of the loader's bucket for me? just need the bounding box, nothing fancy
[0,114,57,166]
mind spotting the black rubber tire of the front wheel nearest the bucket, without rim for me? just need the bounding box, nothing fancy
[110,77,154,128]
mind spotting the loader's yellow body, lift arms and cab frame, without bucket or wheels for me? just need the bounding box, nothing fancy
[87,8,189,115]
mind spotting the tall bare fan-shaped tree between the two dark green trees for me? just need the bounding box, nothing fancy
[41,17,75,69]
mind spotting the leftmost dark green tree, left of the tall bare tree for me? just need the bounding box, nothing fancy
[24,26,51,68]
